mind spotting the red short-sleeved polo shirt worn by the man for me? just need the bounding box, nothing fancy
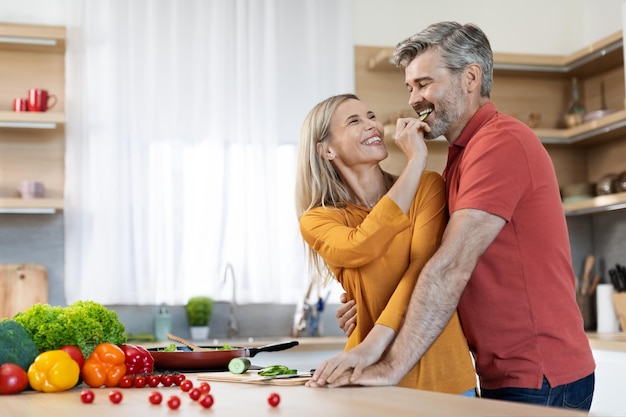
[444,103,595,389]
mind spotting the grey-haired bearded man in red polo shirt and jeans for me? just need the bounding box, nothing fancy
[310,22,595,410]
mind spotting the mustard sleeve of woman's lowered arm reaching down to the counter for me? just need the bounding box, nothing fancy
[376,173,448,333]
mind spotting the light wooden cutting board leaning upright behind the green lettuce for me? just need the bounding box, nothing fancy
[0,264,48,319]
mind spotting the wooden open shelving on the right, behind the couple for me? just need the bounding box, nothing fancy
[355,32,626,216]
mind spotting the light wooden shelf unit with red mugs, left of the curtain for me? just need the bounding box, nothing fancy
[0,23,65,213]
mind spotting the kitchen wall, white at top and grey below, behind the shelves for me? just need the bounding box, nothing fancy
[0,0,626,337]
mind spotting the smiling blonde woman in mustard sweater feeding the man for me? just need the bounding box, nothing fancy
[296,94,476,394]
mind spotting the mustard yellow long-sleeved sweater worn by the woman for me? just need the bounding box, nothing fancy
[300,171,476,394]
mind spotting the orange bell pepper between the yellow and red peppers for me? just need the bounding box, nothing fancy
[81,342,126,388]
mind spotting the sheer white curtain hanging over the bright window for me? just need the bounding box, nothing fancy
[65,0,354,304]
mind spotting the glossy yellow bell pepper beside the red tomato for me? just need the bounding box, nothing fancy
[28,350,80,392]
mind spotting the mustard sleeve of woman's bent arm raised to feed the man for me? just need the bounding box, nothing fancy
[300,196,411,268]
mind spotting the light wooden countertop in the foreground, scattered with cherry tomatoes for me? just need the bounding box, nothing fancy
[0,374,587,417]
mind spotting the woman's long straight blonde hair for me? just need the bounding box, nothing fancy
[296,94,394,286]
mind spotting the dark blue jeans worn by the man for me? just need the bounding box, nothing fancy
[481,373,595,411]
